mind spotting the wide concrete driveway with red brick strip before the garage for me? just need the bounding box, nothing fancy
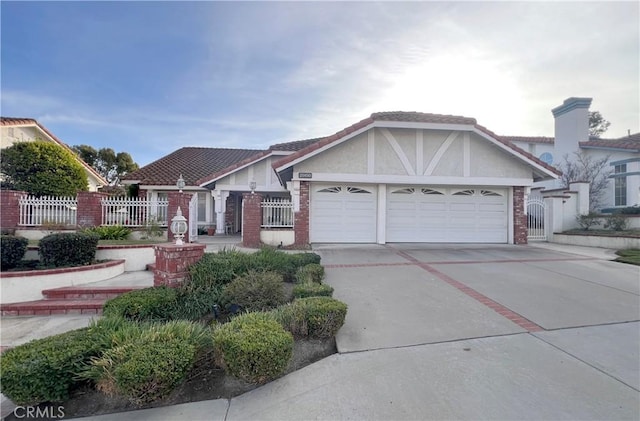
[61,244,640,421]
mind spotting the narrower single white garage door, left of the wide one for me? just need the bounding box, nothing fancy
[309,184,377,243]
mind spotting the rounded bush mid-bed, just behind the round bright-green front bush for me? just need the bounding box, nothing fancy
[223,270,287,311]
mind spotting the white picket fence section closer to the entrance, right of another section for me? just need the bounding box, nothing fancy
[102,197,169,227]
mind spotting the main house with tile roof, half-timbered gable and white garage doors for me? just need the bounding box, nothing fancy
[124,112,560,244]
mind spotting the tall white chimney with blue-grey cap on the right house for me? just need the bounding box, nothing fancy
[551,97,592,164]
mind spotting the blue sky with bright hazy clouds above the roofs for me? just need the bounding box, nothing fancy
[0,0,640,166]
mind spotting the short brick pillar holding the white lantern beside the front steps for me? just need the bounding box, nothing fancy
[153,244,206,287]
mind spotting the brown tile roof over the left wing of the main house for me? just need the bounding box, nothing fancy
[124,147,265,186]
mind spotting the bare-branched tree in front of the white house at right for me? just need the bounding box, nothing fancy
[558,152,611,211]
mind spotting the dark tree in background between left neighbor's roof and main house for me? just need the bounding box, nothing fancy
[71,145,139,186]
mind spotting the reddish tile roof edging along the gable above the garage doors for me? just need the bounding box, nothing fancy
[273,111,561,175]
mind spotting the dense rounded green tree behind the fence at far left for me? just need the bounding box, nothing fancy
[0,140,88,196]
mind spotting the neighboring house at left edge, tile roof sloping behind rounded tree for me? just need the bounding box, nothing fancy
[0,117,109,191]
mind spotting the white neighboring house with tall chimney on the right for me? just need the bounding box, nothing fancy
[510,98,640,211]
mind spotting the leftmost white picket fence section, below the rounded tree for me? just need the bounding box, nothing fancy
[18,196,78,227]
